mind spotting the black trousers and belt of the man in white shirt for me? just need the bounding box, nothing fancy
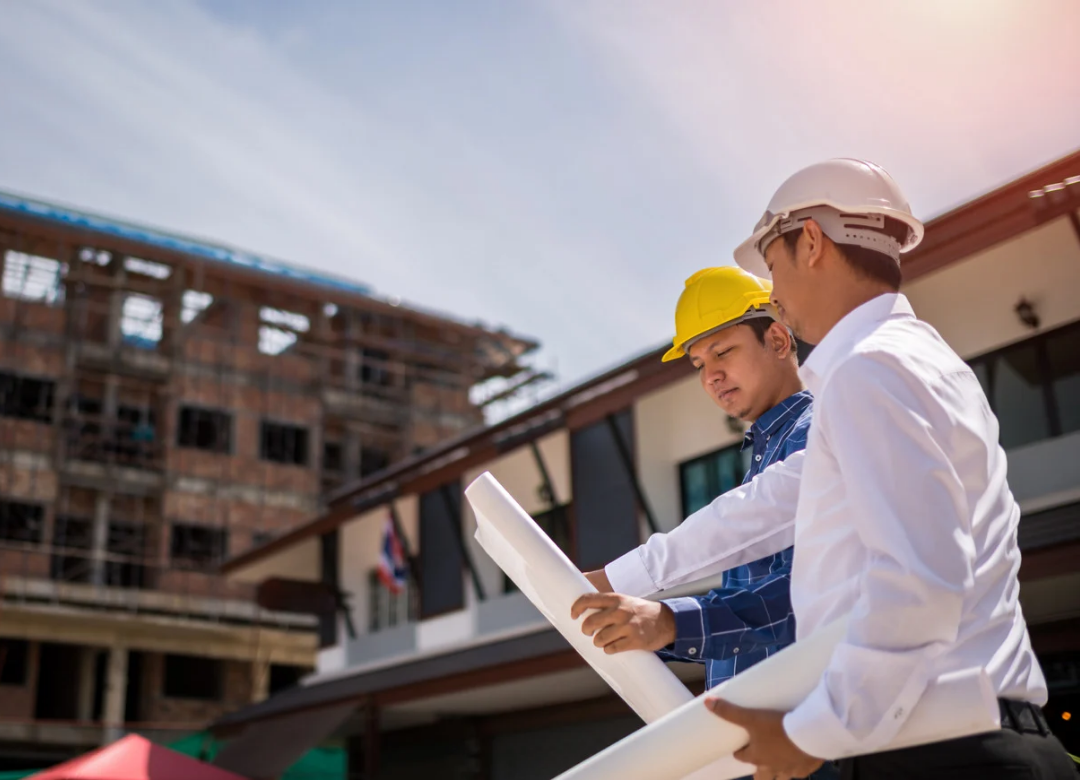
[840,701,1080,780]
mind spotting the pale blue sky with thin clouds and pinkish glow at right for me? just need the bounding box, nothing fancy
[0,0,1080,412]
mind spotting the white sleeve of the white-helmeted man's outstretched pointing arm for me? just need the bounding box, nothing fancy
[604,449,813,597]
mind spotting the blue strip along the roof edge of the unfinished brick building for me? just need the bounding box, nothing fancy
[0,191,373,295]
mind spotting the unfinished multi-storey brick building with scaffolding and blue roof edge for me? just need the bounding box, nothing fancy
[0,193,543,769]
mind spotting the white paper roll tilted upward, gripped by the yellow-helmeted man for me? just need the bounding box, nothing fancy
[465,472,693,723]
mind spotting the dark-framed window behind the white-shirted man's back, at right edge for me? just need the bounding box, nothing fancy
[968,323,1080,449]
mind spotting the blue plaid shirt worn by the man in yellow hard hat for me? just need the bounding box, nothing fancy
[660,390,813,688]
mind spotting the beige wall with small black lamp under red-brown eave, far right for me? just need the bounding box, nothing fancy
[904,212,1080,358]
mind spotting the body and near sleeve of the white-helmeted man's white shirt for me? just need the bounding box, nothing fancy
[781,295,1047,758]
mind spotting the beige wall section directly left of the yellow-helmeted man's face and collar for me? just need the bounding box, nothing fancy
[634,376,742,530]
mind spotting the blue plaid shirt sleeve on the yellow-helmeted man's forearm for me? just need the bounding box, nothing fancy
[662,566,795,661]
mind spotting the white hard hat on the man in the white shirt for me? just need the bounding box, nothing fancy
[735,159,922,279]
